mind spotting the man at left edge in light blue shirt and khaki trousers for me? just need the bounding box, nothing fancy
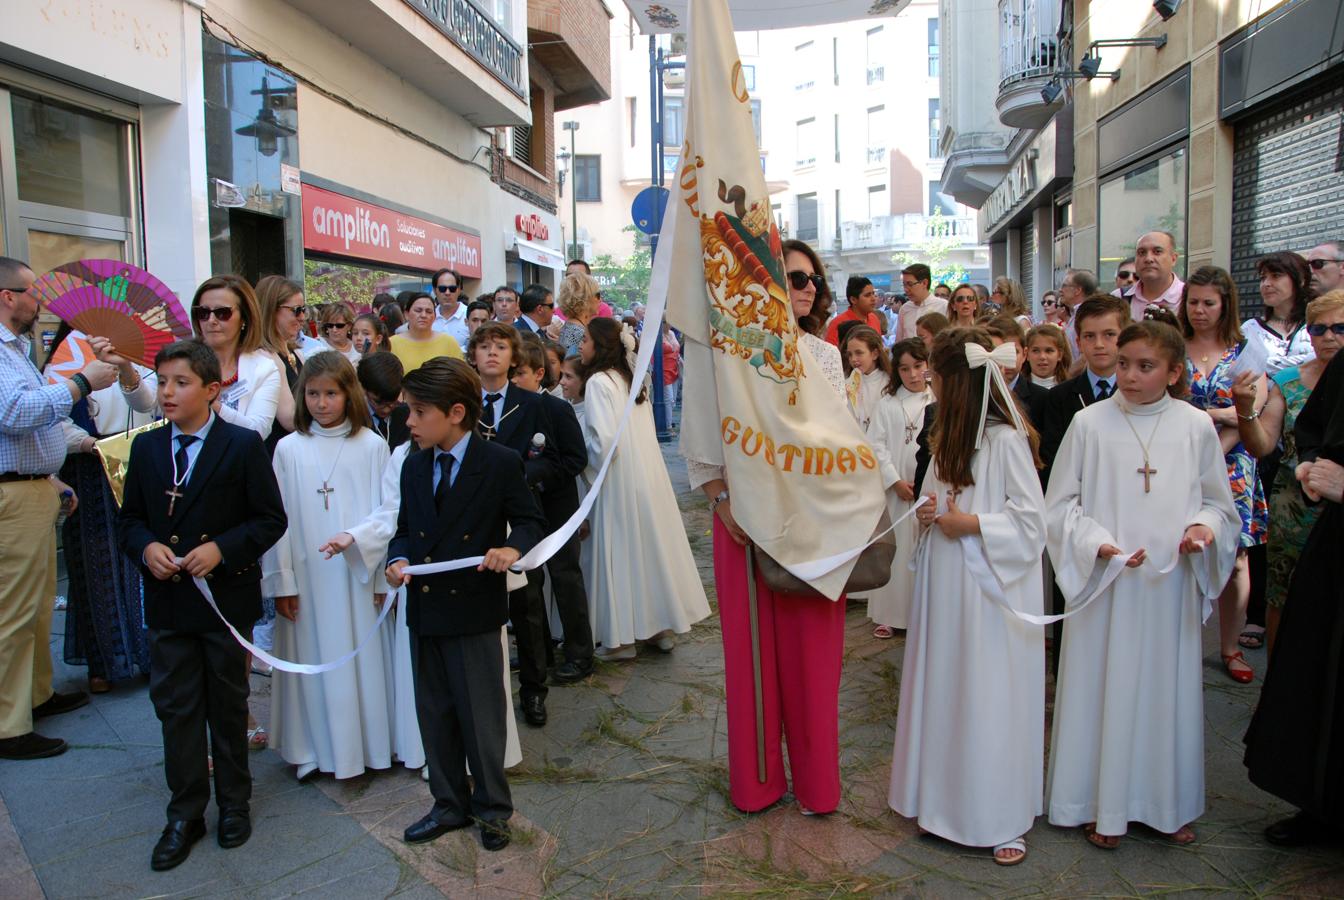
[0,257,117,759]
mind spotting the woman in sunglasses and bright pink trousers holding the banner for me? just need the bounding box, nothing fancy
[687,240,847,815]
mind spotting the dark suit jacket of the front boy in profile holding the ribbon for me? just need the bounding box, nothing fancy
[387,434,546,635]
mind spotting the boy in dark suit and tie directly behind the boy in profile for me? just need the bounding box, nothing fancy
[466,322,574,728]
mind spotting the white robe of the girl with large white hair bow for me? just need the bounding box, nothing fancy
[887,424,1046,846]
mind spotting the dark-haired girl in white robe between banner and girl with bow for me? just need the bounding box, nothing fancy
[868,339,933,639]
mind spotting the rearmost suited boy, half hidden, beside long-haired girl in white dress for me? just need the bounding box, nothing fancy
[513,338,593,684]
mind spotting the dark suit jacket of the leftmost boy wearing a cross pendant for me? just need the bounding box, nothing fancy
[117,416,288,631]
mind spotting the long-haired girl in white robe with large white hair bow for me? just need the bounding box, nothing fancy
[888,328,1046,865]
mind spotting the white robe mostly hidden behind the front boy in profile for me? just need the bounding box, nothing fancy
[343,441,523,774]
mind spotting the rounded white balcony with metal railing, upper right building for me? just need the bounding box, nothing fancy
[995,0,1059,129]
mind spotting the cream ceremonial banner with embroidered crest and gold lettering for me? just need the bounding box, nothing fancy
[650,0,886,599]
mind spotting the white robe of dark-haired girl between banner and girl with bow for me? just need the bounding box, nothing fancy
[868,384,933,629]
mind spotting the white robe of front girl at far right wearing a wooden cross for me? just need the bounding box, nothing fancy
[1047,395,1241,836]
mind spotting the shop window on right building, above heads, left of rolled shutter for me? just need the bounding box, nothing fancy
[1097,144,1187,285]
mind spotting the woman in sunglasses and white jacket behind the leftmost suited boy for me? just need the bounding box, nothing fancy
[191,274,284,439]
